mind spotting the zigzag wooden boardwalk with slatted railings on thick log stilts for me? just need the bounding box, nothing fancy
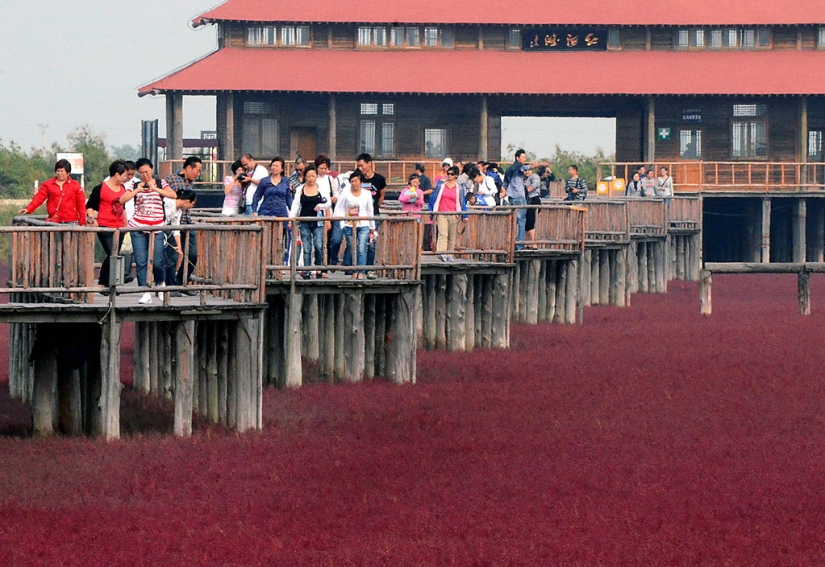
[6,199,701,438]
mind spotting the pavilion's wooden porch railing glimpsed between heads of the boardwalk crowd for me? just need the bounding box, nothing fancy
[158,158,441,186]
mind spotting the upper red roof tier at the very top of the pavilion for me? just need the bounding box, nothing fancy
[194,0,825,26]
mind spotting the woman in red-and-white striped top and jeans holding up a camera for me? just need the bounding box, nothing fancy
[120,158,176,305]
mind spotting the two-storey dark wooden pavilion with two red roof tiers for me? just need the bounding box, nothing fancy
[139,0,825,258]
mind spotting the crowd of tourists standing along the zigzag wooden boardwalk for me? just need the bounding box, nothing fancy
[20,149,673,296]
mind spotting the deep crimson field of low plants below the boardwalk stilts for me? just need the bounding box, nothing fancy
[0,275,825,566]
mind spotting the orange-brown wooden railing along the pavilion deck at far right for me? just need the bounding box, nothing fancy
[597,161,825,193]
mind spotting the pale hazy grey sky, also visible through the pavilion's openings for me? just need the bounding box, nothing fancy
[0,0,615,156]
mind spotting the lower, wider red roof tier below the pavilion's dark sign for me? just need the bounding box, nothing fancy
[138,48,825,96]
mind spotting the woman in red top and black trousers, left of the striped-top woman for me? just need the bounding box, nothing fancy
[86,160,129,287]
